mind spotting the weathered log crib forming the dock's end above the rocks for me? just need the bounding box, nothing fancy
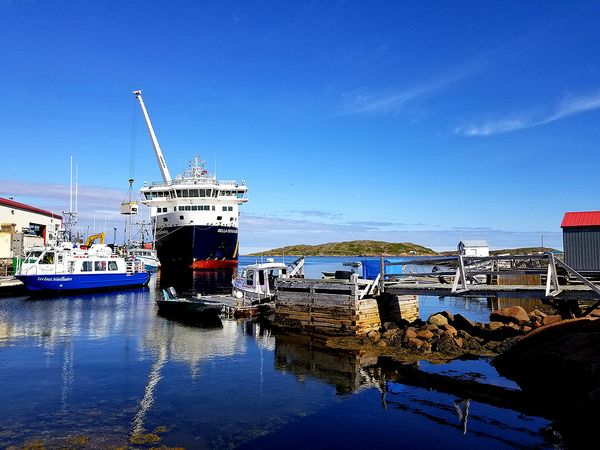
[275,279,381,335]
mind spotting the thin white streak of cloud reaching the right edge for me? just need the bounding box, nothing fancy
[454,91,600,136]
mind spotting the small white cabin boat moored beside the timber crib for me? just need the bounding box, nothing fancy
[232,257,304,310]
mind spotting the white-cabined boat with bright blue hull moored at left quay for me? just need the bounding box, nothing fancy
[15,241,150,293]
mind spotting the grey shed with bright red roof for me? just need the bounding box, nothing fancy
[560,211,600,272]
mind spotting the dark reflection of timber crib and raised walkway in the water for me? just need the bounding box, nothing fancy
[270,333,548,448]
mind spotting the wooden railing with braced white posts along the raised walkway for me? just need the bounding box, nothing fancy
[379,253,600,312]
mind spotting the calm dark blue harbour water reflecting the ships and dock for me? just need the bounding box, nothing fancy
[0,258,564,449]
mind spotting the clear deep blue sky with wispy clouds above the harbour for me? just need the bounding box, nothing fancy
[0,0,600,252]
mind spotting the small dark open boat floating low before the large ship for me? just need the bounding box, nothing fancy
[156,287,224,325]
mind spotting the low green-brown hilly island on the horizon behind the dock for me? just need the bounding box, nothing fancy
[248,241,438,256]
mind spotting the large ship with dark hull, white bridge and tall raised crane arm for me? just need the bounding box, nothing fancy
[133,91,248,269]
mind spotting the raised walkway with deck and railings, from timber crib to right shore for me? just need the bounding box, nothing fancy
[377,253,600,316]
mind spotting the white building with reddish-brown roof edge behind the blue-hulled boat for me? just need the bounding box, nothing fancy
[0,198,62,259]
